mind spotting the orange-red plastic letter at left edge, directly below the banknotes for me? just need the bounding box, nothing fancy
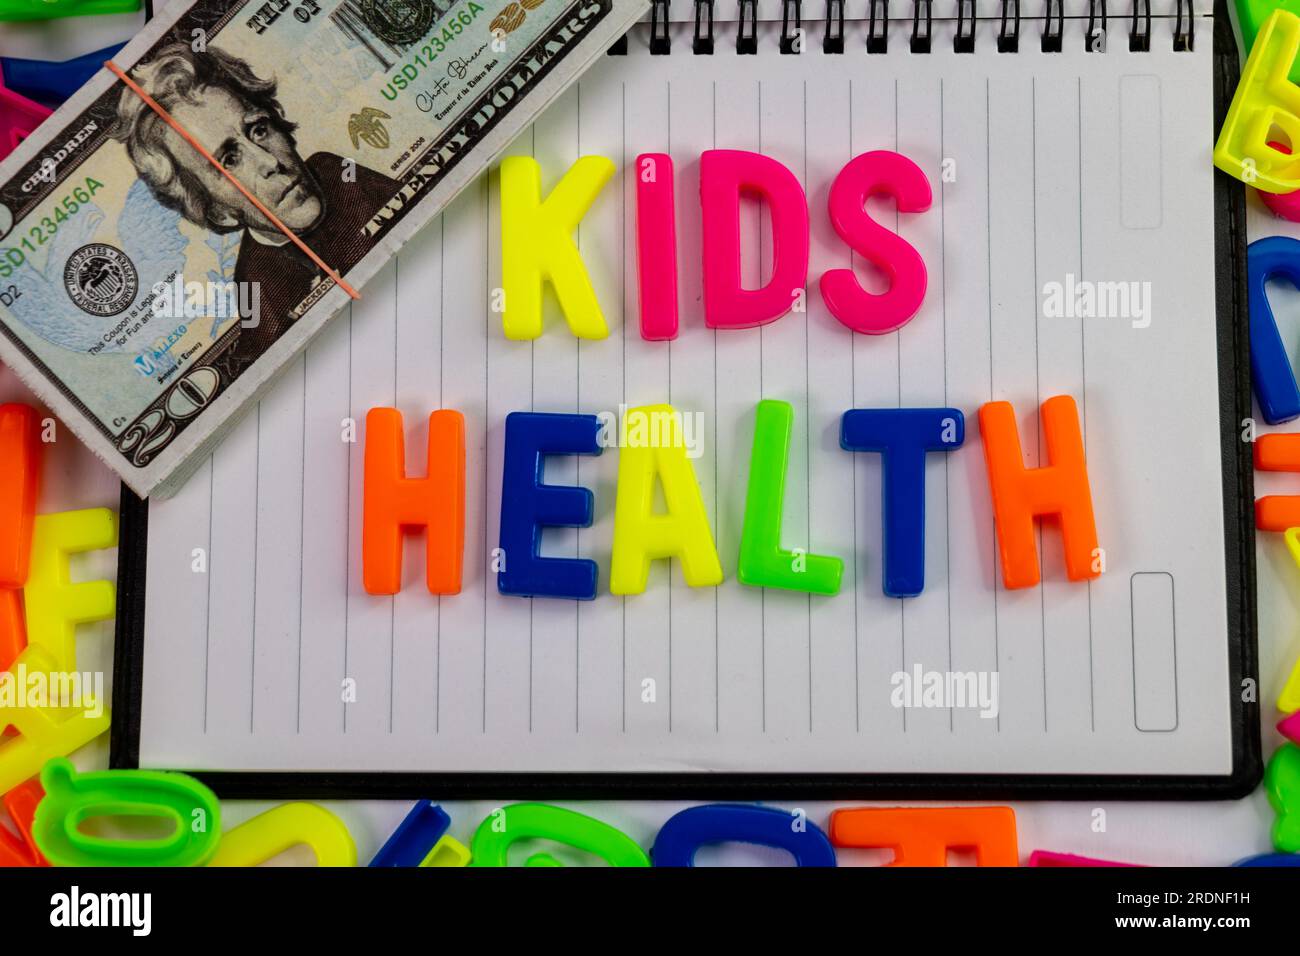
[0,402,40,588]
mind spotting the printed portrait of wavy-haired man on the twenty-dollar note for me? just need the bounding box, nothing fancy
[112,43,400,380]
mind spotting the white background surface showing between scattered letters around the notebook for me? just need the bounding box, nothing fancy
[0,3,1284,865]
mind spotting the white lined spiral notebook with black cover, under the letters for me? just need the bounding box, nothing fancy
[114,0,1258,797]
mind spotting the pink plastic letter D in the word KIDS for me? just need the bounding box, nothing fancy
[699,150,809,329]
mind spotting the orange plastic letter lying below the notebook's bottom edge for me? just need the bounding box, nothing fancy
[831,806,1019,866]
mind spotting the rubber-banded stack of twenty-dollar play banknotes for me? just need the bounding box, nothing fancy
[0,0,645,494]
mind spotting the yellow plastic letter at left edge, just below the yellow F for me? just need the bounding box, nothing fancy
[0,645,112,793]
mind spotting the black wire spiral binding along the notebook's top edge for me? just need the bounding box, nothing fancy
[624,0,1196,56]
